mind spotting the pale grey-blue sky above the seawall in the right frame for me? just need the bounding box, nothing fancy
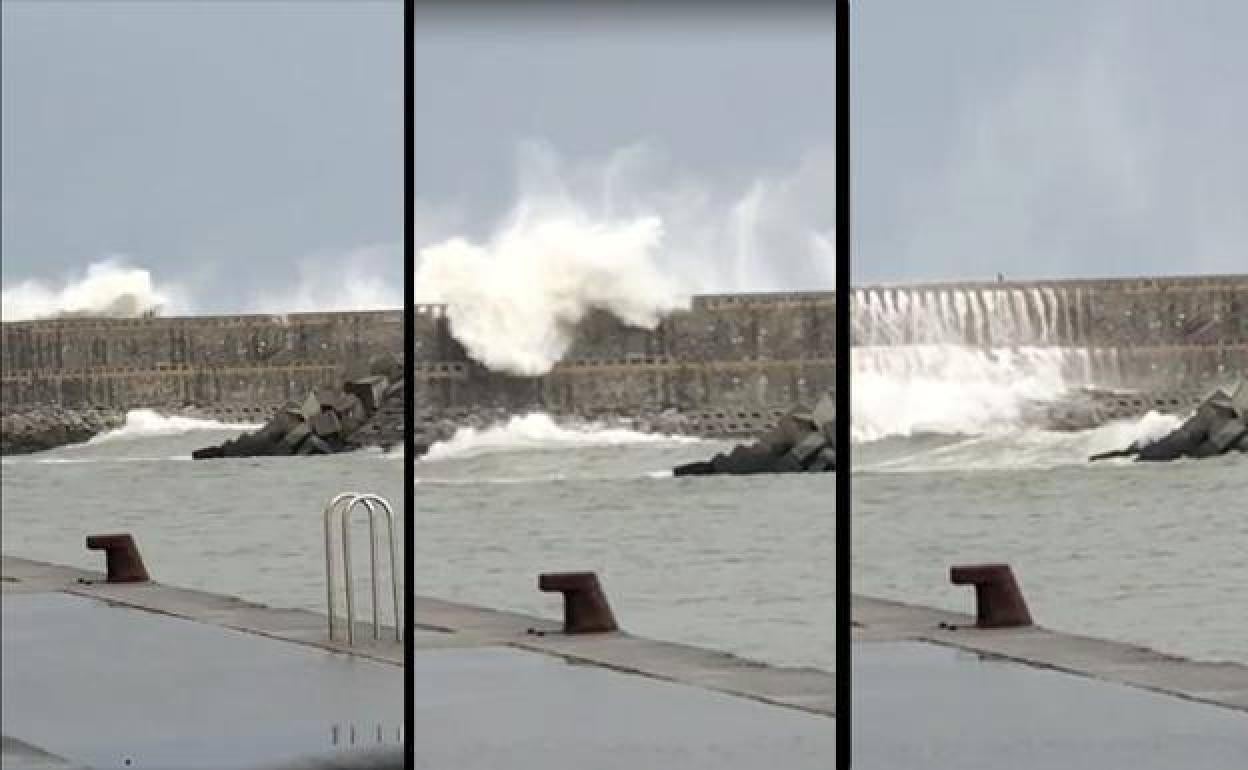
[852,0,1248,282]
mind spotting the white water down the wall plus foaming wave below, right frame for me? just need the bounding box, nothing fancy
[851,287,1181,472]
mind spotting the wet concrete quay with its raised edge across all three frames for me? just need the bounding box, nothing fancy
[2,557,1248,770]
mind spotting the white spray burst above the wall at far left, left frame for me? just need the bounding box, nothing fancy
[0,258,186,321]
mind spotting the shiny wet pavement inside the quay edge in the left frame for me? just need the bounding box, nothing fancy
[2,593,403,769]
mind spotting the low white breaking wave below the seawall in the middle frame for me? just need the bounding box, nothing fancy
[424,413,700,462]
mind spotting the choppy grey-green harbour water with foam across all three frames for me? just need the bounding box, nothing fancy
[0,409,1248,668]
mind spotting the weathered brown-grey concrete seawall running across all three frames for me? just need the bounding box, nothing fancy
[0,275,1248,424]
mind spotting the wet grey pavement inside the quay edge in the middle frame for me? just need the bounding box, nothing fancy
[413,648,836,770]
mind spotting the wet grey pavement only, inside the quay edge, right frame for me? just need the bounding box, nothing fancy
[854,641,1248,770]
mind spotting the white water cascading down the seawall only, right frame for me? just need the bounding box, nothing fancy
[851,287,1093,441]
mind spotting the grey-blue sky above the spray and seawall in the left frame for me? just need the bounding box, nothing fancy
[2,0,403,311]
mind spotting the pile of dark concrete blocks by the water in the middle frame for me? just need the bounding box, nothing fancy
[671,394,836,475]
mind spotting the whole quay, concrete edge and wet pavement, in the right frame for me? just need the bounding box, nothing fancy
[854,597,1248,770]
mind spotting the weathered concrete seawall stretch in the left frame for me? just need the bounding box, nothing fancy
[0,311,403,408]
